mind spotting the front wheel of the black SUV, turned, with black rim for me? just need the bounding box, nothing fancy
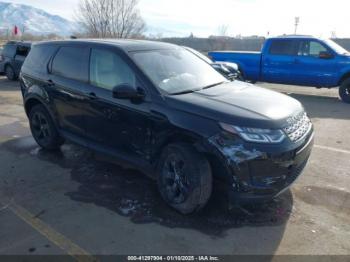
[157,143,212,214]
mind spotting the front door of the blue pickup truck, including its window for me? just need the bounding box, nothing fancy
[293,39,337,87]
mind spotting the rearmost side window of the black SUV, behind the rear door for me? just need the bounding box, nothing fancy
[23,45,57,72]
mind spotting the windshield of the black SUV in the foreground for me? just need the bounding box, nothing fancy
[132,48,227,94]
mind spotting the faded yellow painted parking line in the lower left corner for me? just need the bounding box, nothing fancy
[2,201,98,262]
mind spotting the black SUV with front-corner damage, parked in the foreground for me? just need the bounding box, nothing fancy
[20,40,313,214]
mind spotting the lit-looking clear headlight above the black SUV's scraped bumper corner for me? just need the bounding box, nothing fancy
[220,123,286,144]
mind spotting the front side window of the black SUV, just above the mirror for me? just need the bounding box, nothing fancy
[90,49,136,90]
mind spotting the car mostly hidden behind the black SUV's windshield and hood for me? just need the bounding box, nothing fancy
[183,46,244,81]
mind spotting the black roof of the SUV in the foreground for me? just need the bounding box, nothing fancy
[37,39,178,52]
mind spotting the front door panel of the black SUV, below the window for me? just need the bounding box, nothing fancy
[86,87,151,158]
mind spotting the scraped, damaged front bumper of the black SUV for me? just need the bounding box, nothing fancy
[210,129,314,202]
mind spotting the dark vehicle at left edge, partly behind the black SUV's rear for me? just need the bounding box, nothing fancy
[0,41,31,81]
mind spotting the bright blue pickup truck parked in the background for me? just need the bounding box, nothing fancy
[209,36,350,103]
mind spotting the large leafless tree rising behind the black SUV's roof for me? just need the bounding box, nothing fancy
[77,0,146,38]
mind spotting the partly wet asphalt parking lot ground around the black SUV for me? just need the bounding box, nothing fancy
[0,76,350,255]
